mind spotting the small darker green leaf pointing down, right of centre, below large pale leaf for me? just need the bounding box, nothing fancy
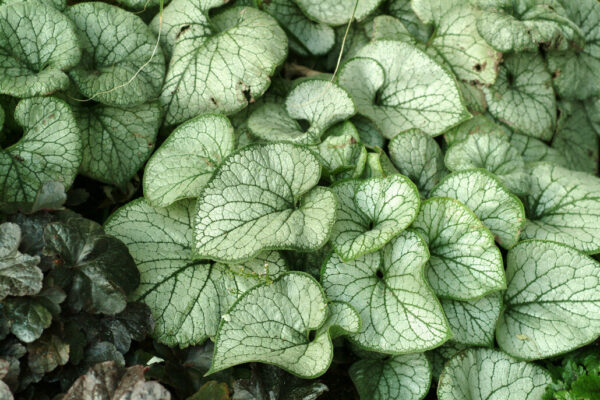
[388,129,448,196]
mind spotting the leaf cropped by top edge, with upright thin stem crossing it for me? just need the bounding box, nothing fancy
[294,0,382,26]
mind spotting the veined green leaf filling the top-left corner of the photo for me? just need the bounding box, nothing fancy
[0,2,81,97]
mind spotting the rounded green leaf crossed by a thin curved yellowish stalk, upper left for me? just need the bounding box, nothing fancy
[66,2,165,106]
